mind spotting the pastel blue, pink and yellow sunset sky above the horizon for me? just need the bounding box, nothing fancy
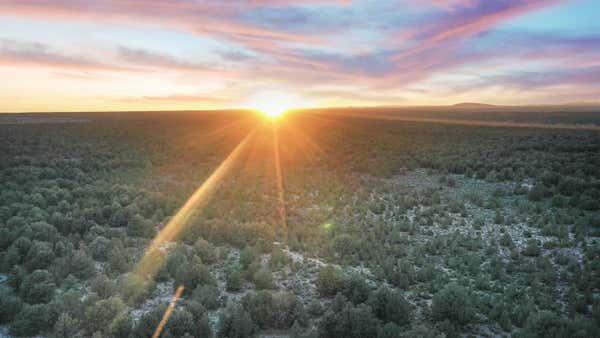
[0,0,600,112]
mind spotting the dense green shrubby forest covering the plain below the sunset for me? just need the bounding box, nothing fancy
[0,111,600,338]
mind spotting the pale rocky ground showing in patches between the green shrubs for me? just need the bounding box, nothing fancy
[0,170,600,338]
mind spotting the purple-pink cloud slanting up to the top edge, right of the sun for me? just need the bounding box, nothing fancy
[336,0,559,88]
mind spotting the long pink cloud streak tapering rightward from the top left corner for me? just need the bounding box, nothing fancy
[0,0,328,43]
